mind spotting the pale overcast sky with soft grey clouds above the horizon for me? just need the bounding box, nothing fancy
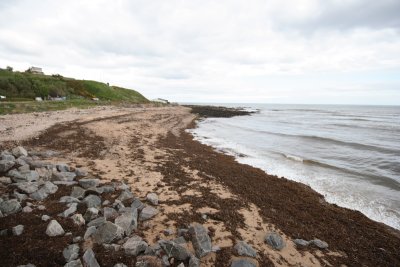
[0,0,400,105]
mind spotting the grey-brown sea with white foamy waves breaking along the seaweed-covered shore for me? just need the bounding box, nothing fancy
[189,104,400,230]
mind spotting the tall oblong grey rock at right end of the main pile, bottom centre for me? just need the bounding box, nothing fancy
[189,223,212,258]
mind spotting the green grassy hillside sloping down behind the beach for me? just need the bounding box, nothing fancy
[0,69,149,103]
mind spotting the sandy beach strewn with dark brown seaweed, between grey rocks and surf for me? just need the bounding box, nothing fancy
[0,107,400,266]
